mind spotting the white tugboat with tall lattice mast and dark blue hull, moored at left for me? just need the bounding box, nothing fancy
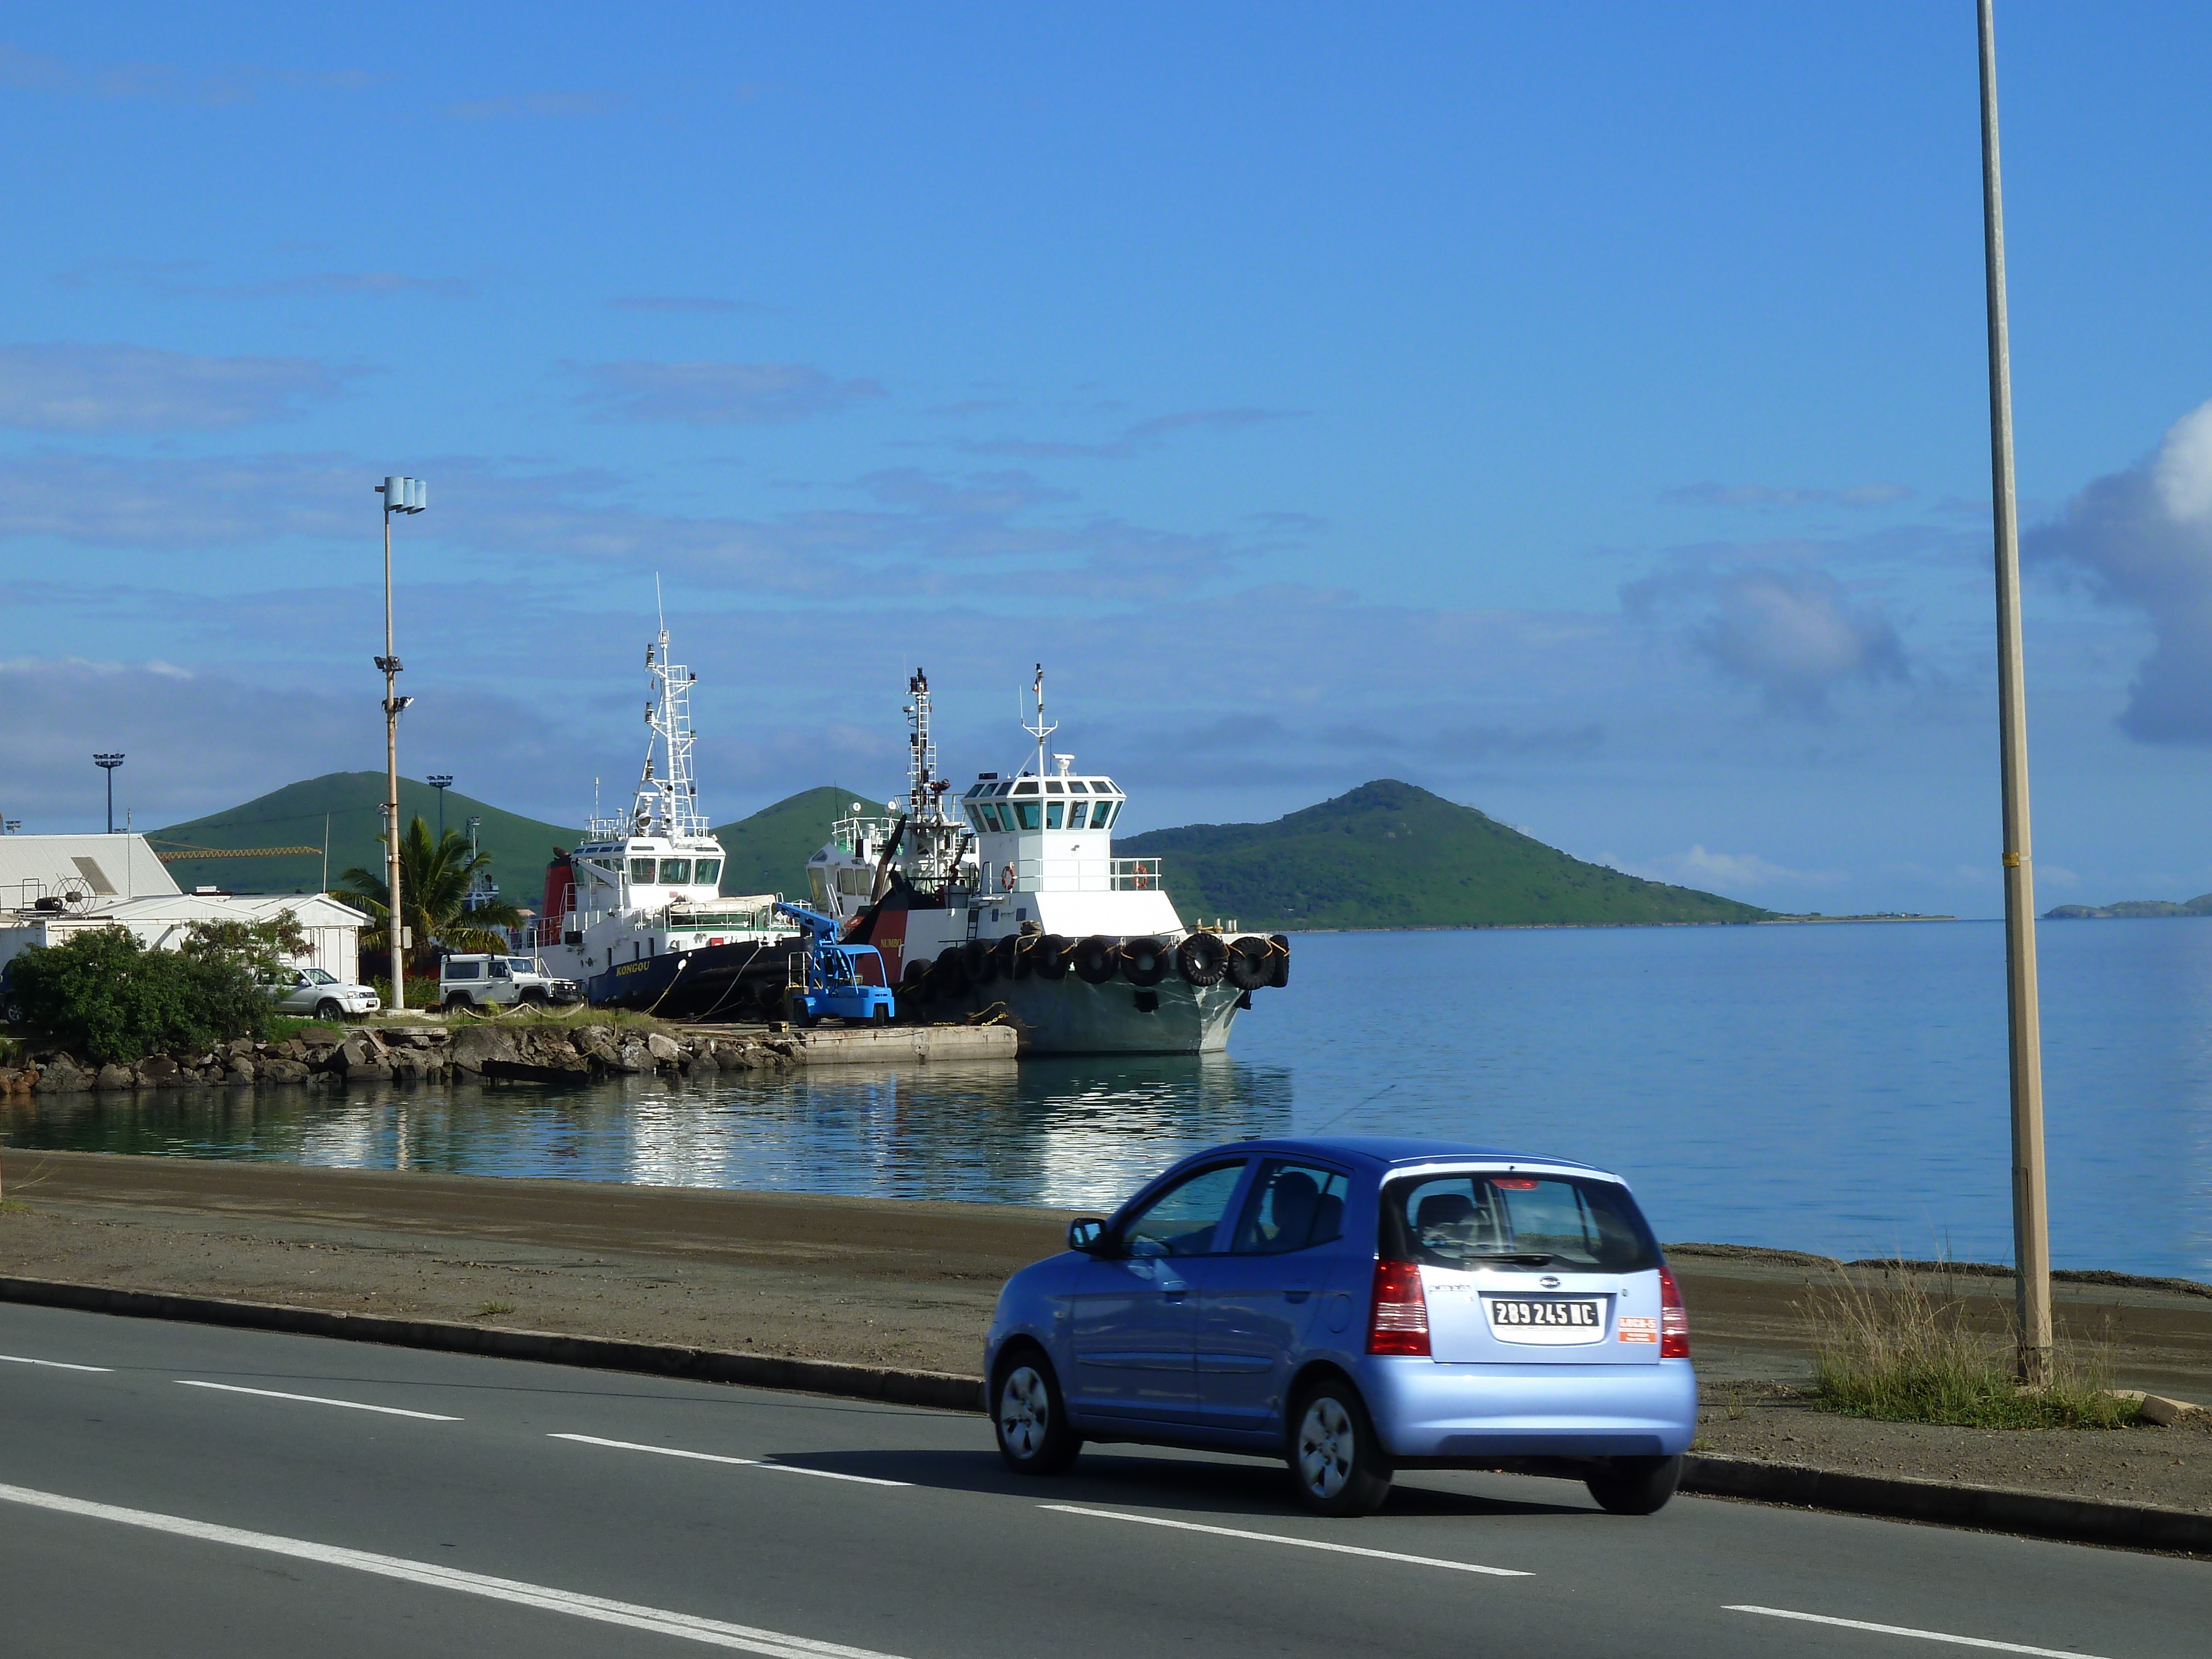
[535,622,801,1020]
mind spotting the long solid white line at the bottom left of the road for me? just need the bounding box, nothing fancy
[0,1486,891,1659]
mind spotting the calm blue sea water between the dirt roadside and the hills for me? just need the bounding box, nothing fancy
[0,920,2212,1279]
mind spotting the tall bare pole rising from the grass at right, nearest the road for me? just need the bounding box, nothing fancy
[1980,0,2051,1383]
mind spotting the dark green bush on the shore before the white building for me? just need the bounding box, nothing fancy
[9,927,272,1064]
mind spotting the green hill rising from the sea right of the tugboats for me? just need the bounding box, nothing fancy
[1115,779,1772,929]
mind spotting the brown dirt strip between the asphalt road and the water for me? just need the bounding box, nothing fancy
[0,1150,2212,1513]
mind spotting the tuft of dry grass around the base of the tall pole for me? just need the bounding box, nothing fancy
[1803,1263,2135,1429]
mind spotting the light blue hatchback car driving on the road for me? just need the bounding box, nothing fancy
[984,1137,1697,1515]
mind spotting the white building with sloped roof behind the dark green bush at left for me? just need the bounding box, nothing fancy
[0,834,369,982]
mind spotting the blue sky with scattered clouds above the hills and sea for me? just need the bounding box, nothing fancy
[0,0,2212,914]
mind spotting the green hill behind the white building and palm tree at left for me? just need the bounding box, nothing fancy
[146,772,577,909]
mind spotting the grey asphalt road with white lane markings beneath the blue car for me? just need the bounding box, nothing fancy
[0,1307,2212,1659]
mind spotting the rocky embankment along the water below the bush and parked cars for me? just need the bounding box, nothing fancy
[0,1024,841,1095]
